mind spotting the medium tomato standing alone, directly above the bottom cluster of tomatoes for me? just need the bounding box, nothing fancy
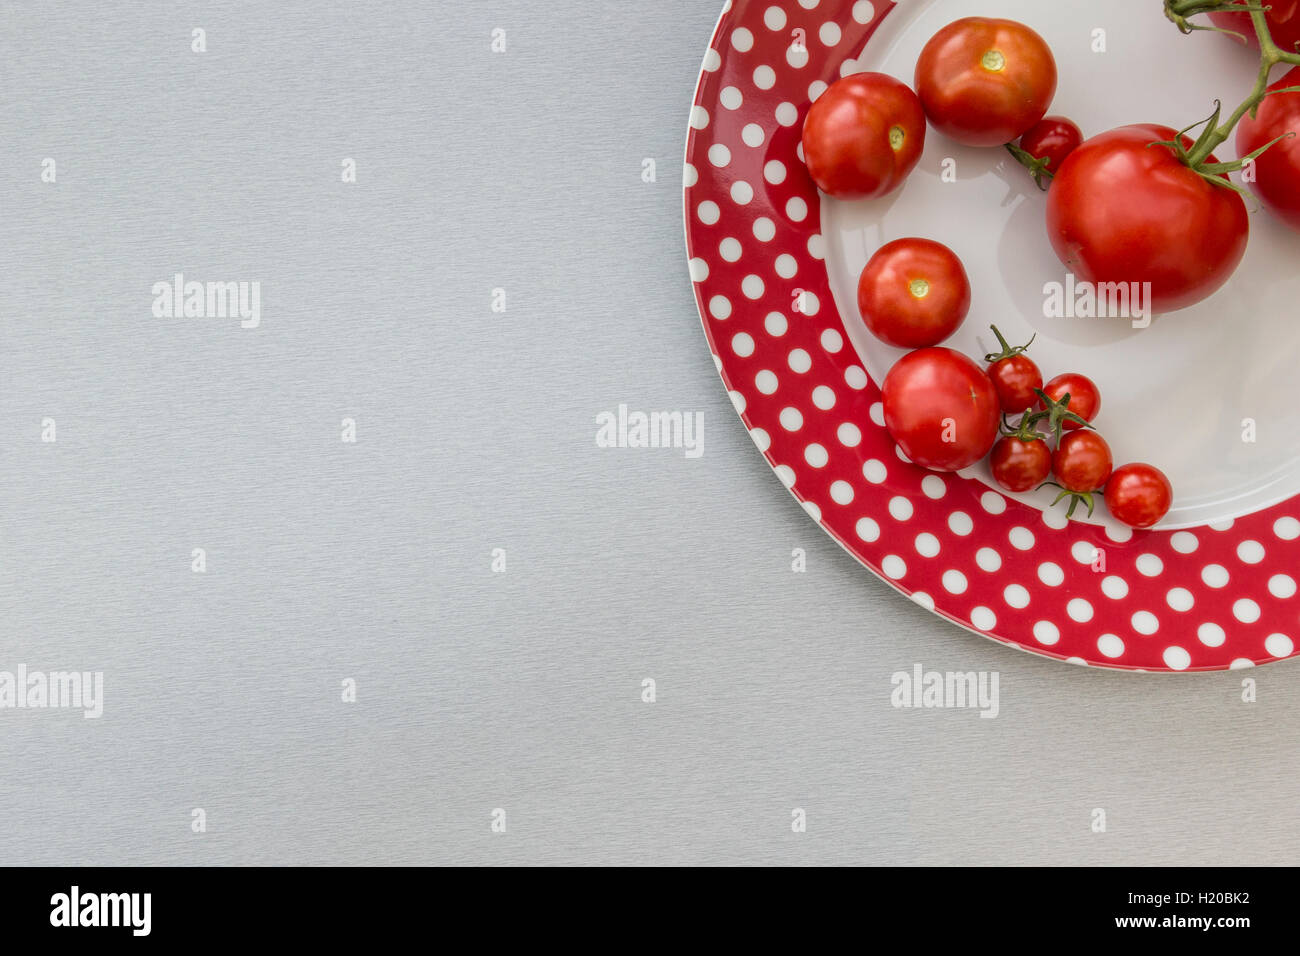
[858,239,971,349]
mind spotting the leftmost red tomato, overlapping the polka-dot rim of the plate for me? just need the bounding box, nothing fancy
[803,73,926,199]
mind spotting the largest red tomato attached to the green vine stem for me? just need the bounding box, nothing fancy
[1047,125,1251,312]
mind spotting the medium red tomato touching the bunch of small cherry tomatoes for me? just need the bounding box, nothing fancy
[881,347,1000,471]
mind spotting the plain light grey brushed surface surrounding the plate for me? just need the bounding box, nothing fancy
[0,0,1300,864]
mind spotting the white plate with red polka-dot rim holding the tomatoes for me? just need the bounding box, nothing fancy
[684,0,1300,671]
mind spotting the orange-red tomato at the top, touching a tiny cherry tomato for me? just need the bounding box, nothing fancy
[915,17,1057,146]
